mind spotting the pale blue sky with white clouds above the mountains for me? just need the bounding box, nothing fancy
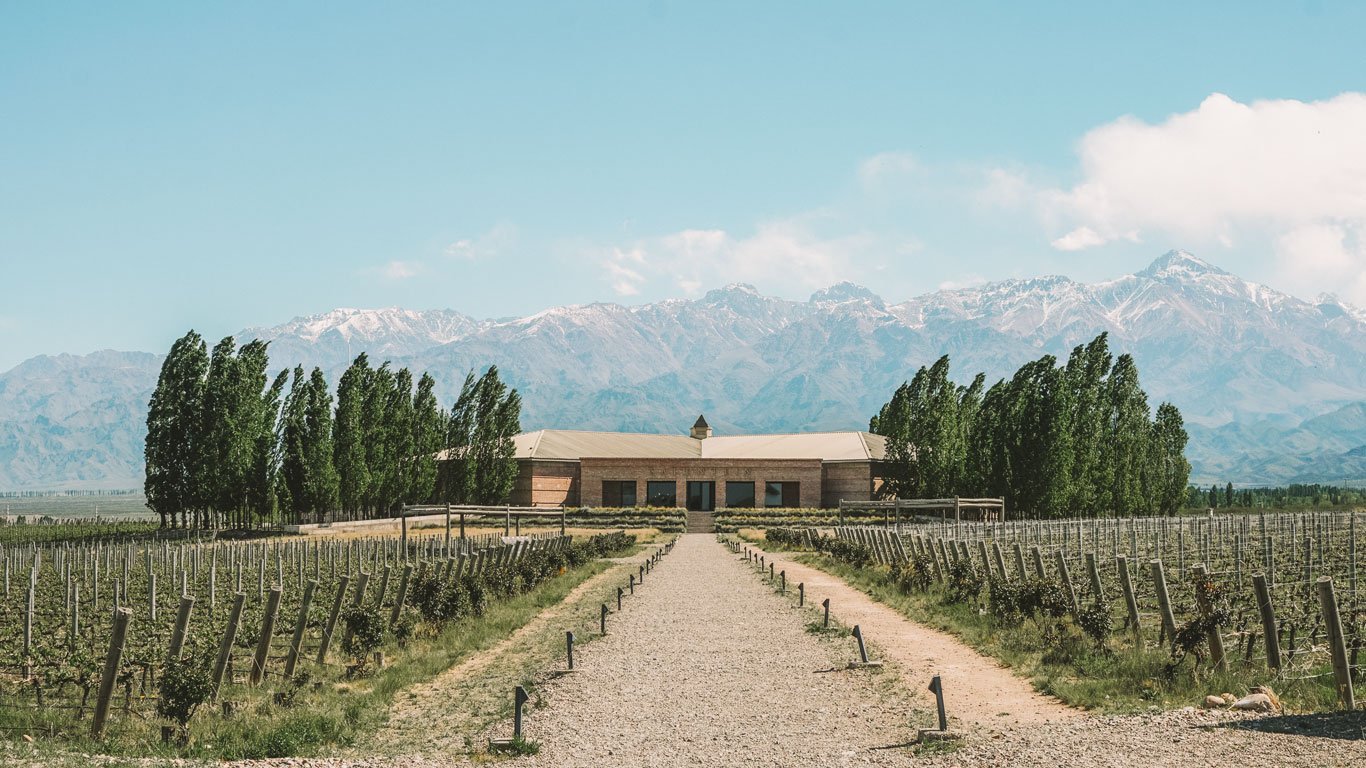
[0,0,1366,370]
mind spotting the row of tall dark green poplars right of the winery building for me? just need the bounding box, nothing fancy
[869,333,1190,517]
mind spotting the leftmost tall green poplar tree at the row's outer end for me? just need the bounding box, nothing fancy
[143,331,209,527]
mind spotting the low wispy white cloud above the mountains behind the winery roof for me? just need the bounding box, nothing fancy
[600,219,867,297]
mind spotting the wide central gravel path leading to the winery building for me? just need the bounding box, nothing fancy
[486,534,914,767]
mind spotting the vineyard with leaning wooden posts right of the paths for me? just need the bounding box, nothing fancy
[768,512,1366,708]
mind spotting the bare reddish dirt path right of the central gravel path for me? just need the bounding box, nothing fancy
[765,552,1082,727]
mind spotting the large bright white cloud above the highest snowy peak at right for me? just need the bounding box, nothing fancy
[1027,93,1366,301]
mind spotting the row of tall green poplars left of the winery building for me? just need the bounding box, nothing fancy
[143,331,522,527]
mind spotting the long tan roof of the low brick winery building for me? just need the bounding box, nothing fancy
[514,429,887,462]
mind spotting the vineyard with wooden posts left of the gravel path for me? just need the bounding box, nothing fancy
[0,524,635,756]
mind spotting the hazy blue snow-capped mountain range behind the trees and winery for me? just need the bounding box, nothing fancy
[0,251,1366,489]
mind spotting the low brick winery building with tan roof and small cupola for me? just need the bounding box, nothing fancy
[511,417,887,511]
